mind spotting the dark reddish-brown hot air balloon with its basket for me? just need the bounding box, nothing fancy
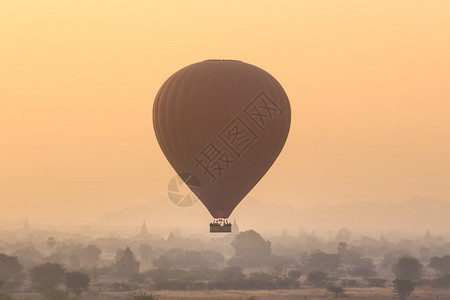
[153,60,291,232]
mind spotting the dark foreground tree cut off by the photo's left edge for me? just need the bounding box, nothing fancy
[0,253,25,292]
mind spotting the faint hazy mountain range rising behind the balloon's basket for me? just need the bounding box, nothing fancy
[90,197,450,233]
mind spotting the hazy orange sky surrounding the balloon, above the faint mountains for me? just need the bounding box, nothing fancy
[0,0,450,223]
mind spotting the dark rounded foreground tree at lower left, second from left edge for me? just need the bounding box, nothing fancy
[30,263,65,292]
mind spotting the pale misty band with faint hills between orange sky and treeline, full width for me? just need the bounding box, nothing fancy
[0,196,450,237]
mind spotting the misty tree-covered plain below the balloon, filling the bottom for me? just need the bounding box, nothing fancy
[0,228,450,300]
